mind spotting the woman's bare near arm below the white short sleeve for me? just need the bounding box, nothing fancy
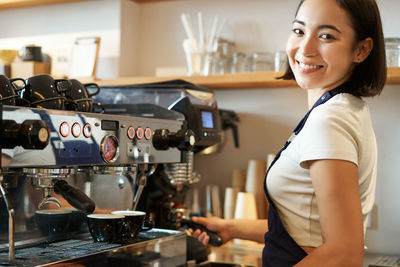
[295,160,364,267]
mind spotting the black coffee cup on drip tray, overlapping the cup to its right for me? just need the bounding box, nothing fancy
[86,214,125,243]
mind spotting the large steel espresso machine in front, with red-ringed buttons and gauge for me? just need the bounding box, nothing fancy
[0,76,196,266]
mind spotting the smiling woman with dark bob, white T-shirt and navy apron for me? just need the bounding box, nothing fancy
[192,0,386,267]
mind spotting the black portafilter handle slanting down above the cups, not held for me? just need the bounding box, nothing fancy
[53,180,96,213]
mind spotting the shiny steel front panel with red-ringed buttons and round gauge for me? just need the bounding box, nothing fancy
[3,106,182,166]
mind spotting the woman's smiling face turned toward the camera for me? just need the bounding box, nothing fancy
[286,0,363,91]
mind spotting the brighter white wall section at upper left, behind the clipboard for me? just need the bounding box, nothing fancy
[0,0,121,78]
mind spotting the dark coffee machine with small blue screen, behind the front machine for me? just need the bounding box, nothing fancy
[95,80,239,262]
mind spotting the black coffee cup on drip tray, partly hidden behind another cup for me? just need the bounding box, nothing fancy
[111,210,150,238]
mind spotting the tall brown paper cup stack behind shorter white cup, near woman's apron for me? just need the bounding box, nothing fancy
[246,160,267,219]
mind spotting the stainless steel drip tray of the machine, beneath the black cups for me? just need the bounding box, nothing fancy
[0,228,186,267]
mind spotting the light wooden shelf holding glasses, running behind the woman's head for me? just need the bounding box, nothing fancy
[91,67,400,90]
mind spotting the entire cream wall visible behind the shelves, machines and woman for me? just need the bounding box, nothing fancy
[0,0,400,254]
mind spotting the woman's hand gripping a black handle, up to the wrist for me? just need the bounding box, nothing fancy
[189,217,232,246]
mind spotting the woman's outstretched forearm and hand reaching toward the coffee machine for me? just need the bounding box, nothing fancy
[192,217,267,245]
